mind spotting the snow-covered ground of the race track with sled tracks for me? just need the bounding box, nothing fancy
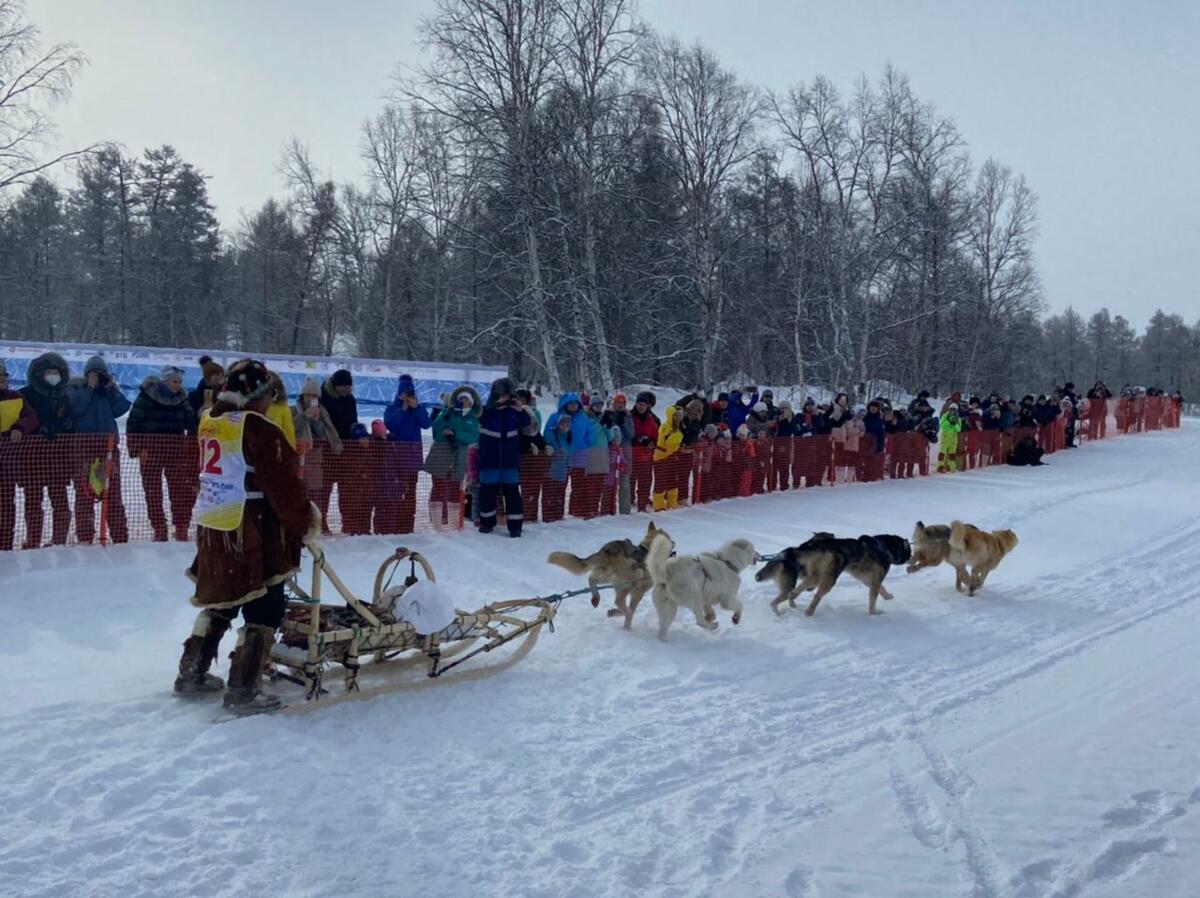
[0,424,1200,898]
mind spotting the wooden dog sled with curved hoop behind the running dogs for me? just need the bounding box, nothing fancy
[270,547,556,714]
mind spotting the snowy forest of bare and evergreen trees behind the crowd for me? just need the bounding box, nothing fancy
[0,0,1200,397]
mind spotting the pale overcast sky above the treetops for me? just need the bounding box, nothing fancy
[28,0,1200,328]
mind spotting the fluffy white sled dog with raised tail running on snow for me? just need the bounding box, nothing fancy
[646,531,756,640]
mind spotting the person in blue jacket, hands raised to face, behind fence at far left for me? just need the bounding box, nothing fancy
[67,355,130,543]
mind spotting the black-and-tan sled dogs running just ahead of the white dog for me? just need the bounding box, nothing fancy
[755,532,912,617]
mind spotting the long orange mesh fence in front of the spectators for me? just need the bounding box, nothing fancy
[0,396,1182,551]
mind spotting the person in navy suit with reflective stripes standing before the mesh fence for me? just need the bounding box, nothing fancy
[478,377,534,538]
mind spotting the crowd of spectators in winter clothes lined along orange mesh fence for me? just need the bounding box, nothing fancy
[0,353,1182,550]
